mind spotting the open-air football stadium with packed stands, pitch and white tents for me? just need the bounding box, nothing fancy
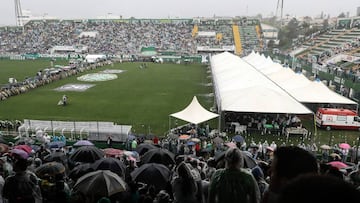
[0,0,360,202]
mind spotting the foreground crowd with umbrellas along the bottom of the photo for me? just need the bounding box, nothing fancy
[0,133,360,203]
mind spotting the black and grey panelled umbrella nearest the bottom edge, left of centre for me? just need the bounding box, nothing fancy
[73,170,126,200]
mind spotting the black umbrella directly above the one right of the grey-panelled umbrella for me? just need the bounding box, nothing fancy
[141,148,175,165]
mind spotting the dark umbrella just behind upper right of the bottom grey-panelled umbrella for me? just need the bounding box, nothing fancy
[91,157,126,178]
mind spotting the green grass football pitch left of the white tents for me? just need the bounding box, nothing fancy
[0,60,216,136]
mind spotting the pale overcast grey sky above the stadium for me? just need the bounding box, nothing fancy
[0,0,360,25]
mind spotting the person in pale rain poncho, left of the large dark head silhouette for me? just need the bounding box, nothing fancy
[209,148,260,203]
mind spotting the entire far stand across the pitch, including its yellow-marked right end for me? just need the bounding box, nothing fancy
[0,18,261,56]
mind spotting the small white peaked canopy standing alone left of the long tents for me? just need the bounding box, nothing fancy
[170,96,219,124]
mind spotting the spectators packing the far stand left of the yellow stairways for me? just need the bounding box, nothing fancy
[0,20,196,55]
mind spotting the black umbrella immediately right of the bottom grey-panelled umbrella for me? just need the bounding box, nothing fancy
[131,163,171,189]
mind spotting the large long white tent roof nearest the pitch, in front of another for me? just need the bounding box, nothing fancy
[211,52,312,114]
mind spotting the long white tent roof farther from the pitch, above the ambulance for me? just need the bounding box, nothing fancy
[243,52,357,105]
